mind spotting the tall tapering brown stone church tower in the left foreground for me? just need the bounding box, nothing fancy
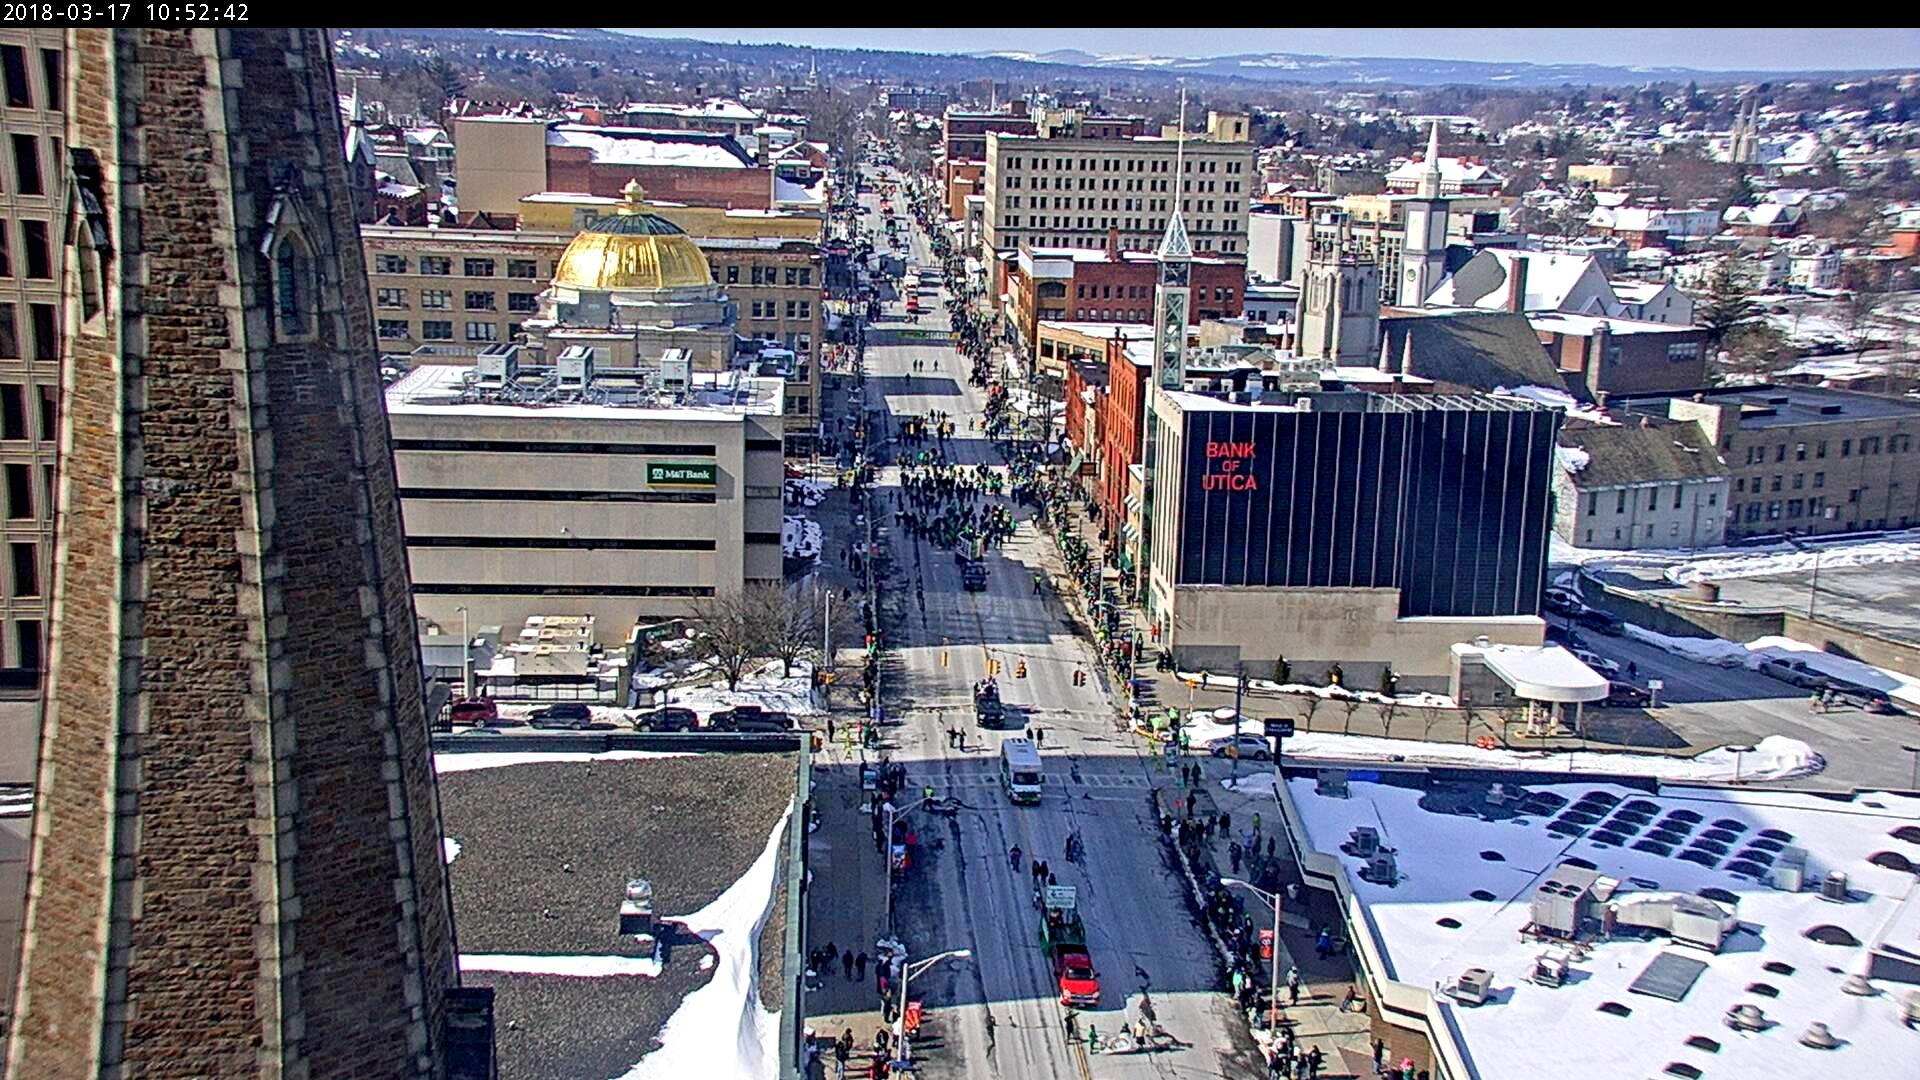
[8,29,461,1080]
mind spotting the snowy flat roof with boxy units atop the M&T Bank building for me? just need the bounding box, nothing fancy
[386,363,783,421]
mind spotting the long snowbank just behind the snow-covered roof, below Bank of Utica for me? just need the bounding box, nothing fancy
[1221,728,1826,776]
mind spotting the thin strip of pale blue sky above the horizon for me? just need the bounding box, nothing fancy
[622,27,1920,71]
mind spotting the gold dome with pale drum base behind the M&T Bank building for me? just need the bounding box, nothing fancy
[524,183,739,371]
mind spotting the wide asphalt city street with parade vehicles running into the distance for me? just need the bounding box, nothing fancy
[816,164,1261,1080]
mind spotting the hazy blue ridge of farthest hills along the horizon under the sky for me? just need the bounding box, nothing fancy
[970,48,1912,88]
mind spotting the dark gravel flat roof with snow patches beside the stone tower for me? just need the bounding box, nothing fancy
[434,751,799,1080]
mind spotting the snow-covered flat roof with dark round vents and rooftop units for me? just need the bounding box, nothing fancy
[1286,774,1920,1080]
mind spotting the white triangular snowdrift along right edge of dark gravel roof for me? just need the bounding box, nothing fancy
[620,809,793,1080]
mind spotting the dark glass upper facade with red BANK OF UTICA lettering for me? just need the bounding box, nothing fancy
[1175,394,1561,617]
